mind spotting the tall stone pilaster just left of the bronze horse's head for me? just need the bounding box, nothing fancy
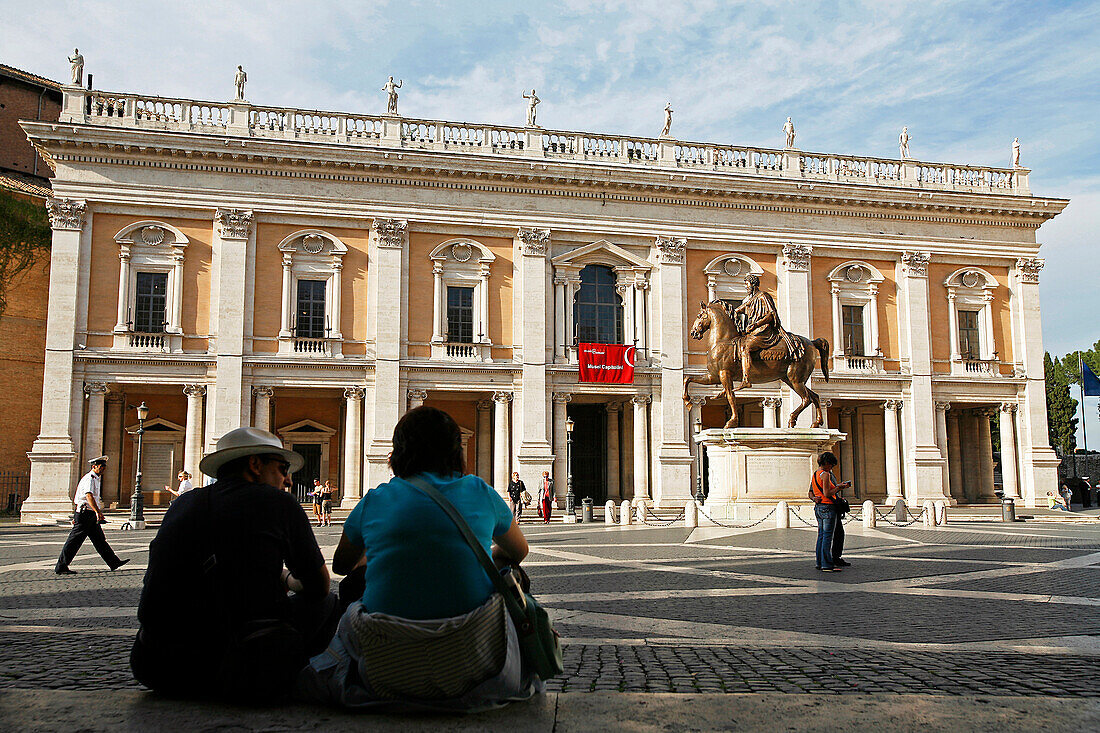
[650,237,695,506]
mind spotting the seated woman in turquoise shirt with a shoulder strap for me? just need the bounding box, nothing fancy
[299,407,542,710]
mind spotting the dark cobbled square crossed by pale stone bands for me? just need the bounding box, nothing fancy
[0,512,1100,698]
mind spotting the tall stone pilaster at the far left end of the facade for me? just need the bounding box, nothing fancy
[20,198,88,523]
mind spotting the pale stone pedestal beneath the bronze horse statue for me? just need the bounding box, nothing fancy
[696,428,847,524]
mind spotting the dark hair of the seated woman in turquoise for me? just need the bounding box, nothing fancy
[389,406,465,479]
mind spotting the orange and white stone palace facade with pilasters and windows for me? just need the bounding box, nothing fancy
[15,81,1066,521]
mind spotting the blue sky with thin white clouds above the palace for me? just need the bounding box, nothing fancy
[0,0,1100,429]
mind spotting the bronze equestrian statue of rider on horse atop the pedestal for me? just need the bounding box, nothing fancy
[684,275,828,428]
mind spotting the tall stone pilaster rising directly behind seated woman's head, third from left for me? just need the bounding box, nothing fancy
[363,219,408,486]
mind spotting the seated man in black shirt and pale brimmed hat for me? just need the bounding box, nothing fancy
[130,428,340,700]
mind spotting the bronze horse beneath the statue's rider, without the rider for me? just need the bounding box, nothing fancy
[684,300,828,428]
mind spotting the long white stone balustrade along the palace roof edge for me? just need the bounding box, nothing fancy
[61,87,1031,196]
